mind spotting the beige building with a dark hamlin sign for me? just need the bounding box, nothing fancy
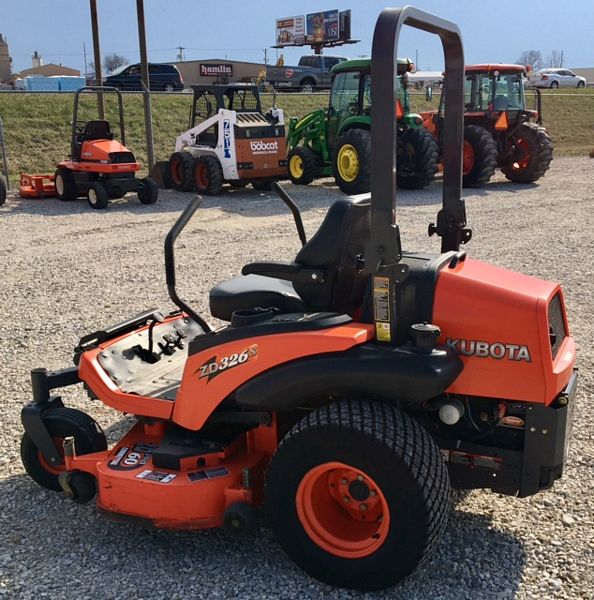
[172,58,264,86]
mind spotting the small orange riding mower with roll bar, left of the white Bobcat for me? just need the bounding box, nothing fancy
[54,86,159,208]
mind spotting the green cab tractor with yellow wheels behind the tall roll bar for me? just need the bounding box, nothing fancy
[287,59,439,194]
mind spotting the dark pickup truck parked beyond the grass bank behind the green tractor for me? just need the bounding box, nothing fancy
[266,54,347,93]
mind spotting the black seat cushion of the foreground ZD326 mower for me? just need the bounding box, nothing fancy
[210,275,305,321]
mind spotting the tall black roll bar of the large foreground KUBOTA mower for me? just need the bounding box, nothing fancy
[366,6,470,264]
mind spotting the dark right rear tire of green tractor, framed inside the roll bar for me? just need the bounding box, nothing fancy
[396,127,439,190]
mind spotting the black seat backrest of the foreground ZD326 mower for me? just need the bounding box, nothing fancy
[293,197,371,313]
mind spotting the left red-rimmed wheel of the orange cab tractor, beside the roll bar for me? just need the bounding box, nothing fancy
[462,125,499,187]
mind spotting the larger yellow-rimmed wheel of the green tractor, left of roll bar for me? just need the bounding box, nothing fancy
[332,129,371,194]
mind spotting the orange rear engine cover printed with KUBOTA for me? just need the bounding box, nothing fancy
[433,259,575,404]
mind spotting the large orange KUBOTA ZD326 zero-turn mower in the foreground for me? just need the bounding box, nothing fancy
[21,7,577,590]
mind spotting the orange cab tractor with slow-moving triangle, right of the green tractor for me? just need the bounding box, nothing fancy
[422,64,553,187]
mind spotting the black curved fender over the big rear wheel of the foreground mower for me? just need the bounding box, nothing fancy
[235,343,463,412]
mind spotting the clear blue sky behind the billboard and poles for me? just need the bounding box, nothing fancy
[0,0,594,73]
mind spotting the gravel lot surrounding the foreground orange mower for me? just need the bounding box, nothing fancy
[0,158,594,599]
